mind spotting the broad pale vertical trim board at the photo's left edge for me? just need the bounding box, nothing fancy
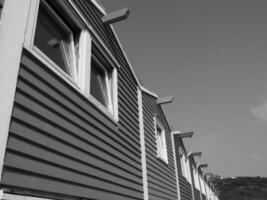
[0,0,31,180]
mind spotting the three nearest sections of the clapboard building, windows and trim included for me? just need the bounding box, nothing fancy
[0,0,221,200]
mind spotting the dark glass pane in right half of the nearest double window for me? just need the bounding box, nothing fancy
[90,60,108,107]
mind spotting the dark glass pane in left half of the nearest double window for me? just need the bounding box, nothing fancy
[34,3,70,74]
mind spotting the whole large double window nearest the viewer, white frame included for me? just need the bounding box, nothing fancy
[25,0,118,121]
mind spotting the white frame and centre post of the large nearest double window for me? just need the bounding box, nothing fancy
[23,0,120,124]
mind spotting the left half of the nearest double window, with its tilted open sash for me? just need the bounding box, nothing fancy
[34,1,77,79]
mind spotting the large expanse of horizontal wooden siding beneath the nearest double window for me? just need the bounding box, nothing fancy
[1,51,143,200]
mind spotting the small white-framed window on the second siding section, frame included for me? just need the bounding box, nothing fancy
[154,117,168,164]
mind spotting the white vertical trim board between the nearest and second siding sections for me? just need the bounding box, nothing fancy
[138,88,148,200]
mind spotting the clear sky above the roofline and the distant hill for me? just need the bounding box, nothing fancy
[102,0,267,177]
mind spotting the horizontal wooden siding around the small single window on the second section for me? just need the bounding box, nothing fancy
[142,92,177,200]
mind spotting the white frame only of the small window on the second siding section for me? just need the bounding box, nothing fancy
[154,116,168,164]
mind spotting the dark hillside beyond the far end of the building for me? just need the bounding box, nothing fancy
[213,177,267,200]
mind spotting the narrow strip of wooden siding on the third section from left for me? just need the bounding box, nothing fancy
[174,135,193,200]
